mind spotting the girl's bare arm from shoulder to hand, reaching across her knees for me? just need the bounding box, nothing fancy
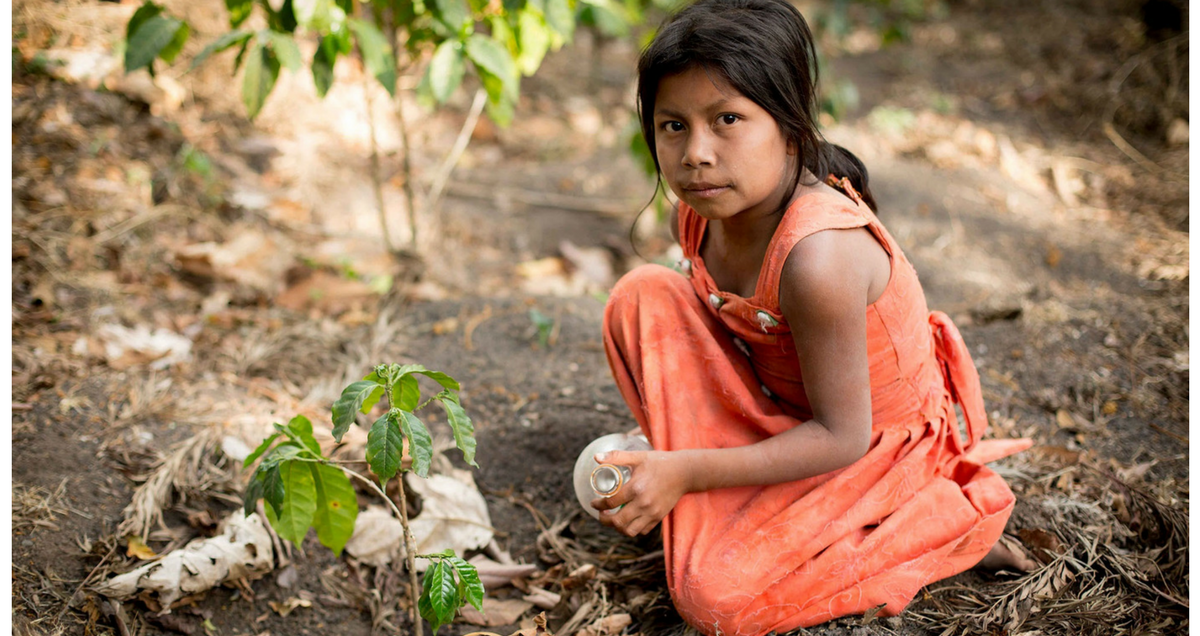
[593,229,889,535]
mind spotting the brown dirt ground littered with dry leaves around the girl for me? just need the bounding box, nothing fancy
[12,0,1190,636]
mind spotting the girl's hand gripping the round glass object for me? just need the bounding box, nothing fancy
[592,450,688,536]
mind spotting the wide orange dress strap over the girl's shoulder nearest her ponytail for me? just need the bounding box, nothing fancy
[758,174,893,307]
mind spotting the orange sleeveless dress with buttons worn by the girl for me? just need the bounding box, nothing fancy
[604,181,1030,636]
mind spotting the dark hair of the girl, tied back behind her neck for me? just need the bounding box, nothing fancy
[637,0,875,211]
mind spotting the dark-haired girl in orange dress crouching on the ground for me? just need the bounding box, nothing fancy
[593,0,1033,636]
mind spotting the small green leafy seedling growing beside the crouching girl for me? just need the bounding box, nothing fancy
[245,365,484,636]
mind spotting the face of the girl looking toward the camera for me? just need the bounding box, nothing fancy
[654,67,796,220]
